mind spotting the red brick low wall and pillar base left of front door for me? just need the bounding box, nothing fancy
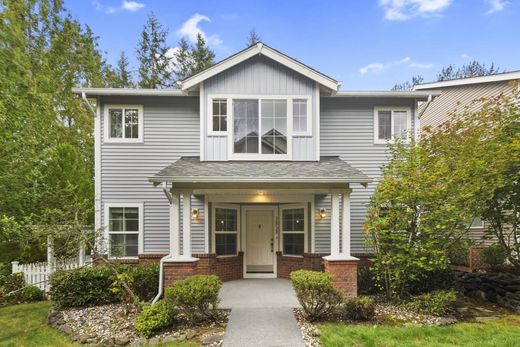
[159,252,243,287]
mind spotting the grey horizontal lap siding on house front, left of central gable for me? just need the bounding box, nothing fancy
[100,97,205,253]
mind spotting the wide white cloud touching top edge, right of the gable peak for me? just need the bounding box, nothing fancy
[379,0,452,21]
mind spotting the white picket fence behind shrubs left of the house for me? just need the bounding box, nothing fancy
[11,258,89,292]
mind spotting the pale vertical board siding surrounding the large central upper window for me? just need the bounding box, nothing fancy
[202,56,317,161]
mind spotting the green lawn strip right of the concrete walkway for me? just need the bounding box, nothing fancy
[320,315,520,347]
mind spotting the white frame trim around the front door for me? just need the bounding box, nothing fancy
[240,205,280,278]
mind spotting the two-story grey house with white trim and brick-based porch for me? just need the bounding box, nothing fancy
[74,44,439,295]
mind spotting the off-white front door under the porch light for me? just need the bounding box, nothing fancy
[244,207,276,277]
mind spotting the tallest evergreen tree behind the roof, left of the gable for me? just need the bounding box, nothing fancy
[137,13,172,88]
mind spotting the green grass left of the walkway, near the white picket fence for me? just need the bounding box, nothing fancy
[0,302,197,347]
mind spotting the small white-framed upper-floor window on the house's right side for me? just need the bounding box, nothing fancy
[374,107,412,143]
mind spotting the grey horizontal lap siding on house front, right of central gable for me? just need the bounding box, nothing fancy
[315,97,415,254]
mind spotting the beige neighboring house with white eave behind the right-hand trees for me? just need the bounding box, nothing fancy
[414,71,520,245]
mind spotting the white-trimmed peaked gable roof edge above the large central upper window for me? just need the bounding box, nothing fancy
[181,43,341,92]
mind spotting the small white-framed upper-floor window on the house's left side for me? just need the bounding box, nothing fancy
[105,105,143,142]
